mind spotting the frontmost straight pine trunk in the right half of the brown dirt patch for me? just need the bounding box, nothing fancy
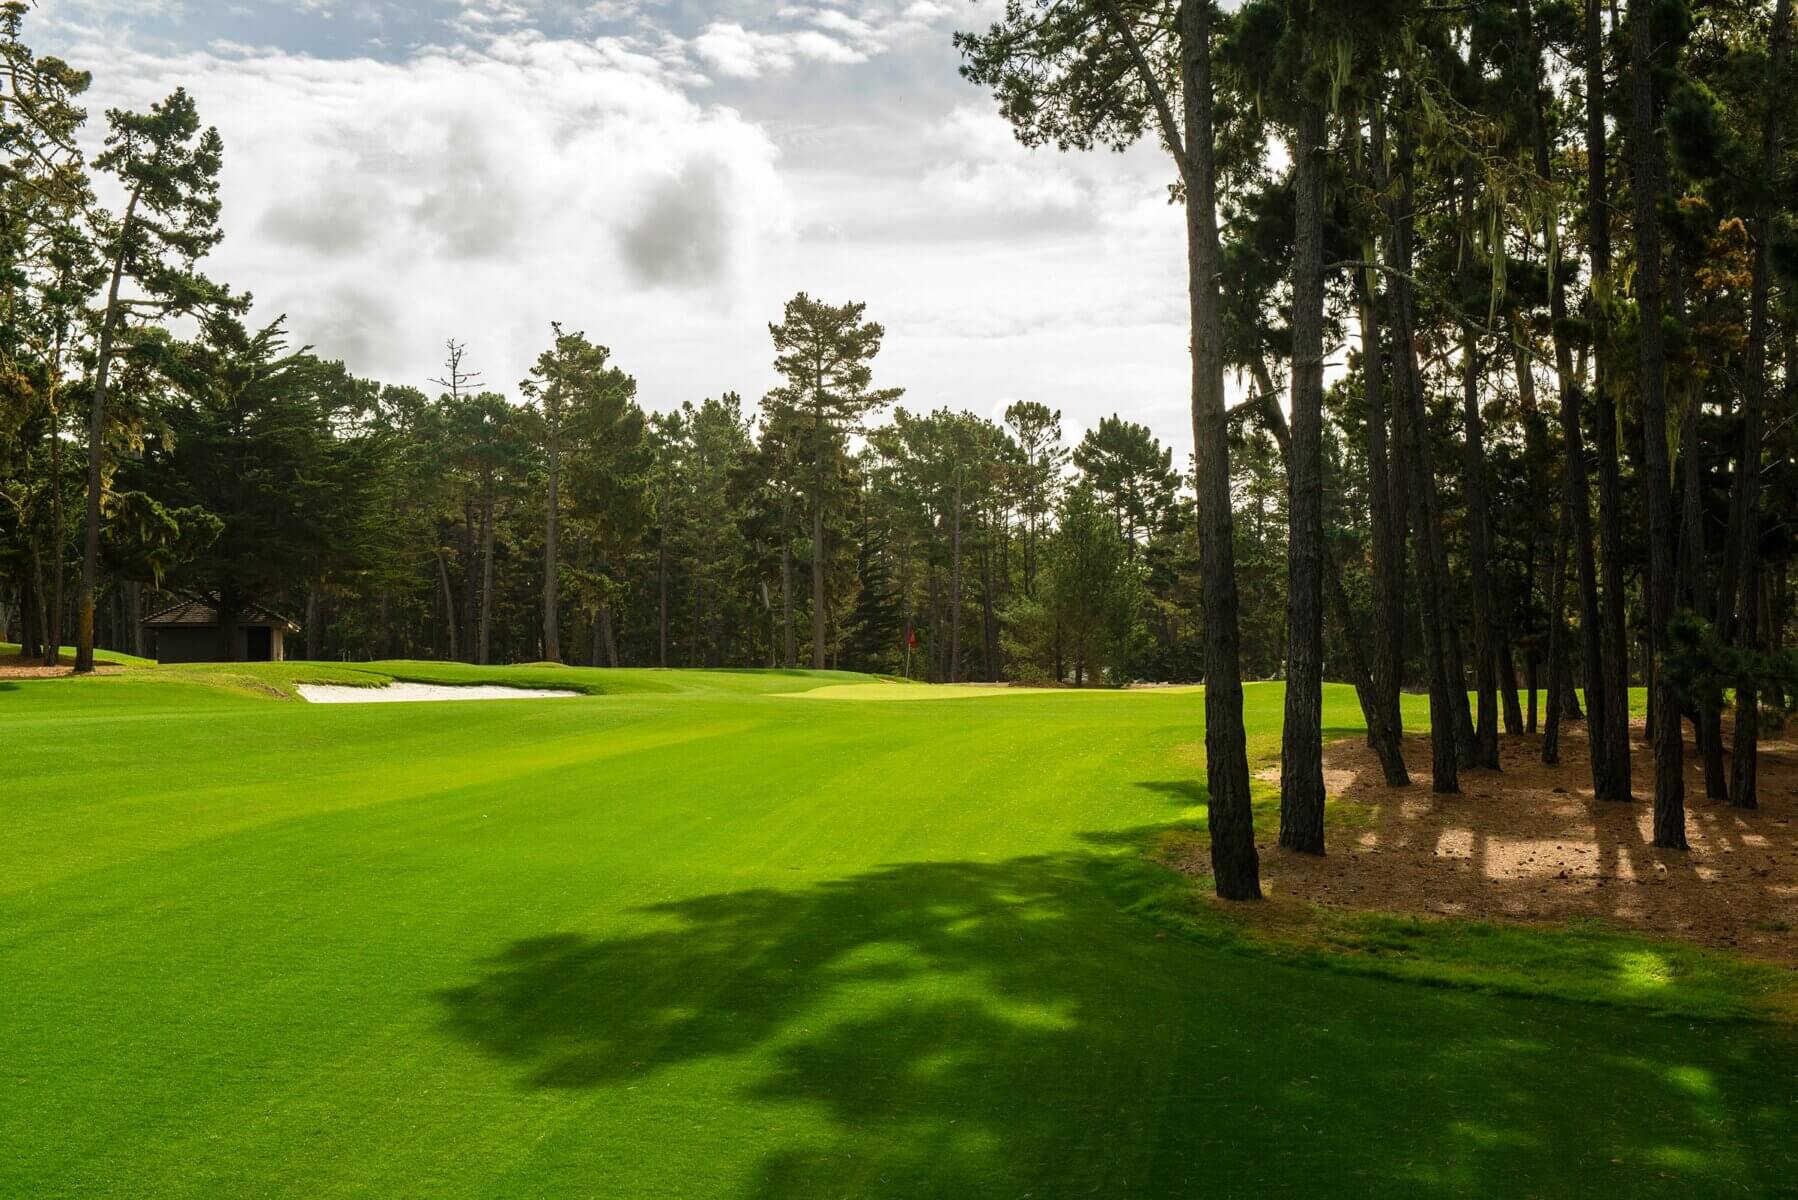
[1629,0,1687,849]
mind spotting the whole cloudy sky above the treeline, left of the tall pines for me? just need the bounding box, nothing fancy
[27,0,1190,453]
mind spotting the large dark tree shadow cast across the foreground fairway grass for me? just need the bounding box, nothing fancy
[441,851,1798,1198]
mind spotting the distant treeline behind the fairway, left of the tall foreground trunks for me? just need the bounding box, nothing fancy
[0,4,1215,684]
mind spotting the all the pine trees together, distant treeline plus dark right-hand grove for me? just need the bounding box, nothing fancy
[0,0,1798,898]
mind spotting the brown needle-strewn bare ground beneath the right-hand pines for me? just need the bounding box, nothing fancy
[1262,725,1798,966]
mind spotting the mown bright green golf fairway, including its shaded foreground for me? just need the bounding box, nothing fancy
[0,664,1798,1200]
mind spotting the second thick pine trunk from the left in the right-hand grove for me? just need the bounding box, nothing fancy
[1280,86,1325,855]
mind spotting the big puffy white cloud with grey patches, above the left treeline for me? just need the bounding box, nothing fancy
[59,36,789,389]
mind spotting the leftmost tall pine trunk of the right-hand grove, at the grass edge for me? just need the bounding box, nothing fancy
[1179,0,1260,900]
